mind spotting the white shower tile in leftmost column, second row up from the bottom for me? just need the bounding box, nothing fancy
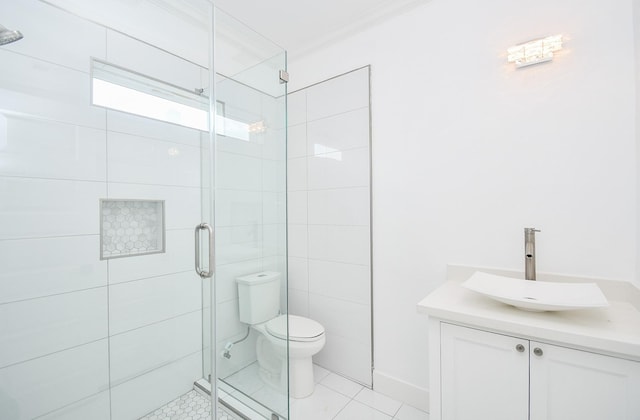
[0,339,109,420]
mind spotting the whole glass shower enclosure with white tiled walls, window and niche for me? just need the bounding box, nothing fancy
[0,0,288,420]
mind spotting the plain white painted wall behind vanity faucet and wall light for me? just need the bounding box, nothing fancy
[289,0,637,404]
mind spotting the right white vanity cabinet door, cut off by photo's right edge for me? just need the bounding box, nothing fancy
[530,341,640,420]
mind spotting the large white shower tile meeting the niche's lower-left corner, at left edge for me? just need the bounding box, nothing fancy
[0,235,107,303]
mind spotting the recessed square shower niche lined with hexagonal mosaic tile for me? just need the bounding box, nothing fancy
[100,199,165,260]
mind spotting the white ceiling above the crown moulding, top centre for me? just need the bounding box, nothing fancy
[214,0,429,57]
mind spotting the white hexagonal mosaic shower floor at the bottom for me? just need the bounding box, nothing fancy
[140,390,240,420]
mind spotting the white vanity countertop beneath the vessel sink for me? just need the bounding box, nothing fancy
[418,270,640,361]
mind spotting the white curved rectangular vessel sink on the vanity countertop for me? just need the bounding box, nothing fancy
[462,271,609,312]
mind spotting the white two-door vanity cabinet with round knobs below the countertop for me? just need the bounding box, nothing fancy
[438,319,640,420]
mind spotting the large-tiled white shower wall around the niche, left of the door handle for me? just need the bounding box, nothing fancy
[0,0,207,420]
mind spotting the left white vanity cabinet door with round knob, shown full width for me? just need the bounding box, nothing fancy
[440,322,528,420]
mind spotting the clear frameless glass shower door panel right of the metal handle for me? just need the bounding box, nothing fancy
[205,9,288,419]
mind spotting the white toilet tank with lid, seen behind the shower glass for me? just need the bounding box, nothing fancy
[236,271,280,325]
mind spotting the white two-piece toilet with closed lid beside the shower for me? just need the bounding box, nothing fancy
[236,271,325,398]
